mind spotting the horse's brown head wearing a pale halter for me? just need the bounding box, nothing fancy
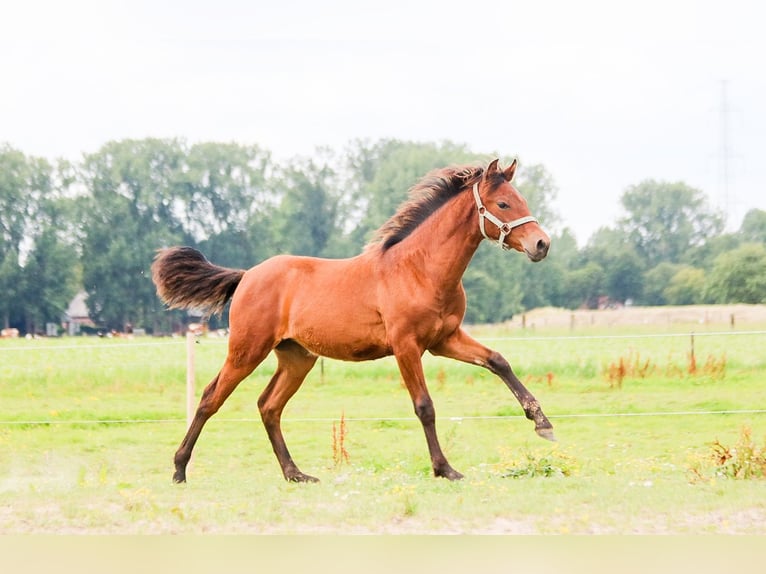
[473,159,551,261]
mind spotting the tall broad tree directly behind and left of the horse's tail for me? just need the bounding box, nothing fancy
[81,139,192,330]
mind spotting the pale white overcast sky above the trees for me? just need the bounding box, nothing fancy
[0,0,766,245]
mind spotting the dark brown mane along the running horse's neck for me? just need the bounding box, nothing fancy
[367,164,484,251]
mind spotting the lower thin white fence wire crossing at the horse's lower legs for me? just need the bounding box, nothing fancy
[0,409,766,426]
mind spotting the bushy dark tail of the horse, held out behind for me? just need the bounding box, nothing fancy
[152,247,245,314]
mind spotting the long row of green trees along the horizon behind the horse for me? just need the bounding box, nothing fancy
[0,139,766,332]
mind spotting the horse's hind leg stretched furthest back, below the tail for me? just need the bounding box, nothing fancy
[173,350,269,482]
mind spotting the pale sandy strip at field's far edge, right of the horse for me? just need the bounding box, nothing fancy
[510,305,766,328]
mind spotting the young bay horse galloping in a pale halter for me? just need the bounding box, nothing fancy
[152,160,555,482]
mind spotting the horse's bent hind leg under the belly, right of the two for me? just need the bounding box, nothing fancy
[258,341,318,482]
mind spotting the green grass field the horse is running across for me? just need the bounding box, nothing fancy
[0,316,766,534]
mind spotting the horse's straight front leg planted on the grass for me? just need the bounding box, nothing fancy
[394,346,463,480]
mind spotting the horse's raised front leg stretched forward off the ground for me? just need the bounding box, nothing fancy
[429,329,556,440]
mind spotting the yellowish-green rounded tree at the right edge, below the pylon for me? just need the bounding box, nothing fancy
[705,243,766,304]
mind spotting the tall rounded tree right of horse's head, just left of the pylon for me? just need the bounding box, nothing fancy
[618,179,724,267]
